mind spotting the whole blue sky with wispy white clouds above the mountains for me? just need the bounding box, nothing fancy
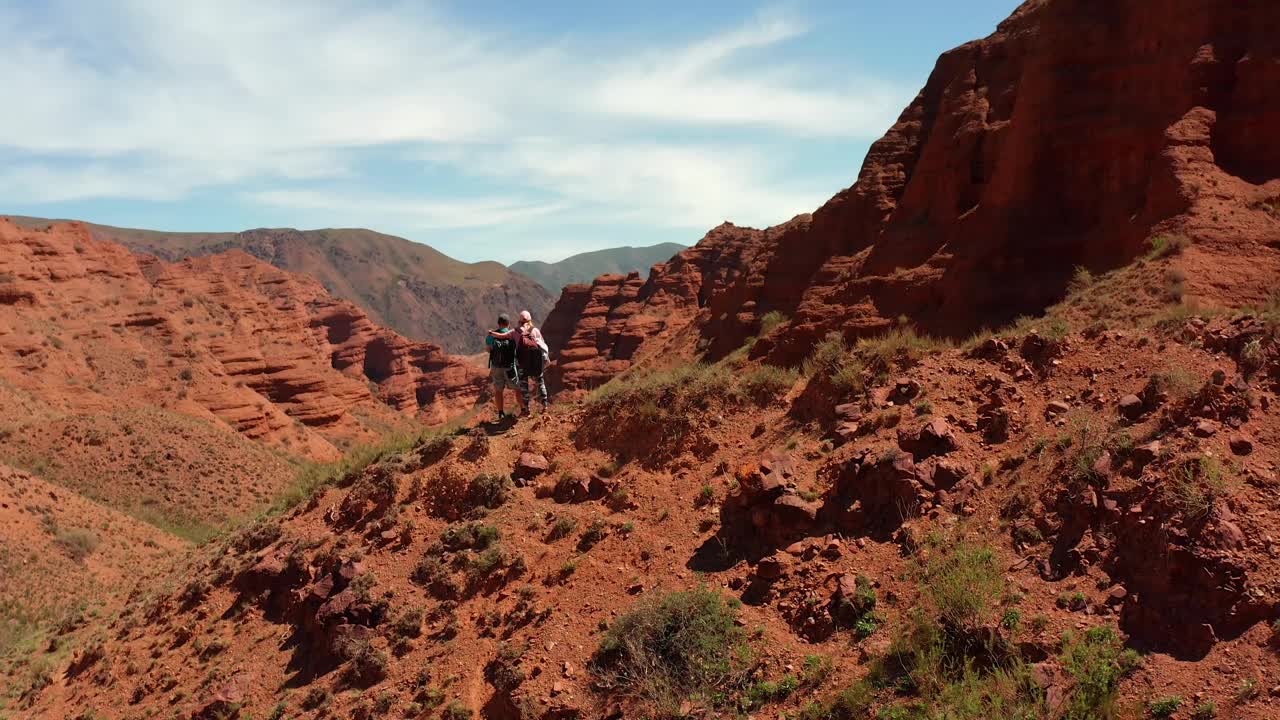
[0,0,1016,263]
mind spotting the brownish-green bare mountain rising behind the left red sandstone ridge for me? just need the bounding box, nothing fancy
[13,217,555,354]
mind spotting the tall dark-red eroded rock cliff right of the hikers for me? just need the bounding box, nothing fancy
[548,0,1280,389]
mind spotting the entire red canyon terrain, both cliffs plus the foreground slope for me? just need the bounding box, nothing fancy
[0,0,1280,720]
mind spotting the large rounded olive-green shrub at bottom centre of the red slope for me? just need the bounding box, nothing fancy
[591,588,750,712]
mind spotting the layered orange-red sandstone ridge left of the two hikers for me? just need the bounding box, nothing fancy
[0,219,485,457]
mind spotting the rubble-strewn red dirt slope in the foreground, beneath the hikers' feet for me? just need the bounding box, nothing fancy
[17,272,1280,720]
